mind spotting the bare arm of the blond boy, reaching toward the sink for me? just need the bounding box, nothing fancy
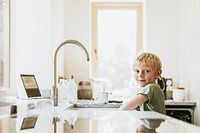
[119,94,148,110]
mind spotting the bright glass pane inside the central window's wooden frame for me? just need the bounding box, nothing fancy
[97,9,137,89]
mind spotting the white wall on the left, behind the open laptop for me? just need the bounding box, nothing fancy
[10,0,64,93]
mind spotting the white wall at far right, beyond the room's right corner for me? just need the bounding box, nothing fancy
[178,0,200,125]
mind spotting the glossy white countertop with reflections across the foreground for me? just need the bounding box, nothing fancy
[0,99,200,133]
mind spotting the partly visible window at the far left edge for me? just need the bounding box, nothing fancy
[0,0,10,87]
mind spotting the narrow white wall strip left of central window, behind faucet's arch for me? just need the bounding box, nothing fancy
[64,0,90,83]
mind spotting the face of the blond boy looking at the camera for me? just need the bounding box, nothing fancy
[134,64,160,87]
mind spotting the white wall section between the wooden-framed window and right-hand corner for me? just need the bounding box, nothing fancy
[146,0,179,84]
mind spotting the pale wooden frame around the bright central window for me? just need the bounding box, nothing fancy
[91,2,143,77]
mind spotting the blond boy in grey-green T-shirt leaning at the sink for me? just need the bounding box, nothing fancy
[120,53,166,132]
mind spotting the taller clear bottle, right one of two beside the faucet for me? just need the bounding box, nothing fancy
[66,75,78,103]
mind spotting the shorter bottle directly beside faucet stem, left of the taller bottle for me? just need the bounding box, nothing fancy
[58,79,67,102]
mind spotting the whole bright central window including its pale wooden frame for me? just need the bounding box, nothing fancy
[92,2,142,89]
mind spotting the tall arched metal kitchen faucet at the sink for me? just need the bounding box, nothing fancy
[52,40,90,106]
